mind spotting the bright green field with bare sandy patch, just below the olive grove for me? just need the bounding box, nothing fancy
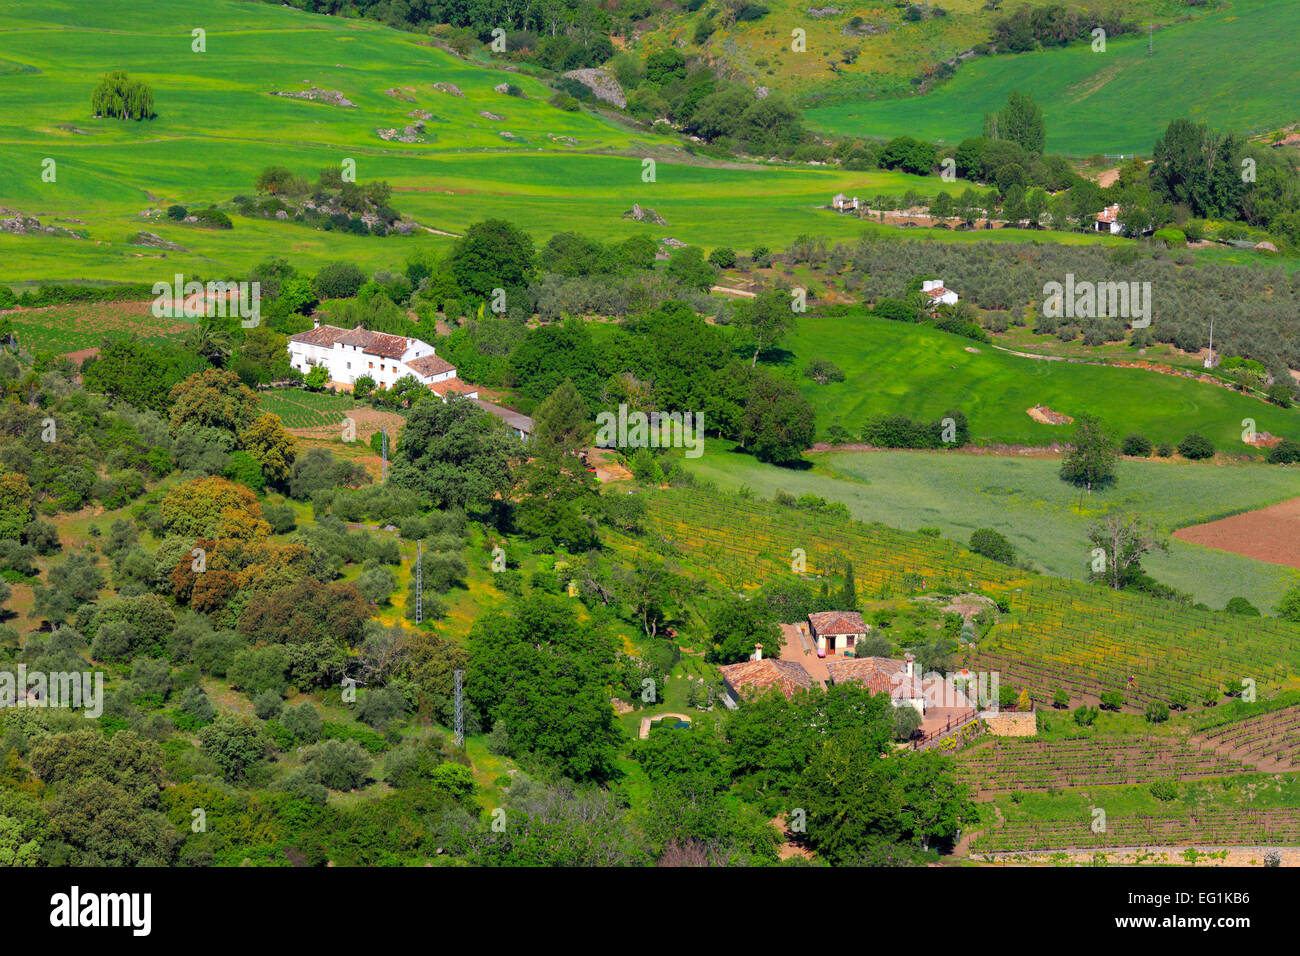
[783,312,1300,454]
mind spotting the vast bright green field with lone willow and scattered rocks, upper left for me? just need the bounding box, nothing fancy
[0,0,1044,281]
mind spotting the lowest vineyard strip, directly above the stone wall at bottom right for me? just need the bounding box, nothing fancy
[971,808,1300,853]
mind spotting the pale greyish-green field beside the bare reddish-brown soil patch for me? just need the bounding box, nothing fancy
[686,442,1300,611]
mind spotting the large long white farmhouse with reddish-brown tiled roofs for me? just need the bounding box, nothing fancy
[289,323,478,398]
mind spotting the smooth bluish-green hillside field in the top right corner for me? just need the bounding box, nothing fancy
[807,0,1300,156]
